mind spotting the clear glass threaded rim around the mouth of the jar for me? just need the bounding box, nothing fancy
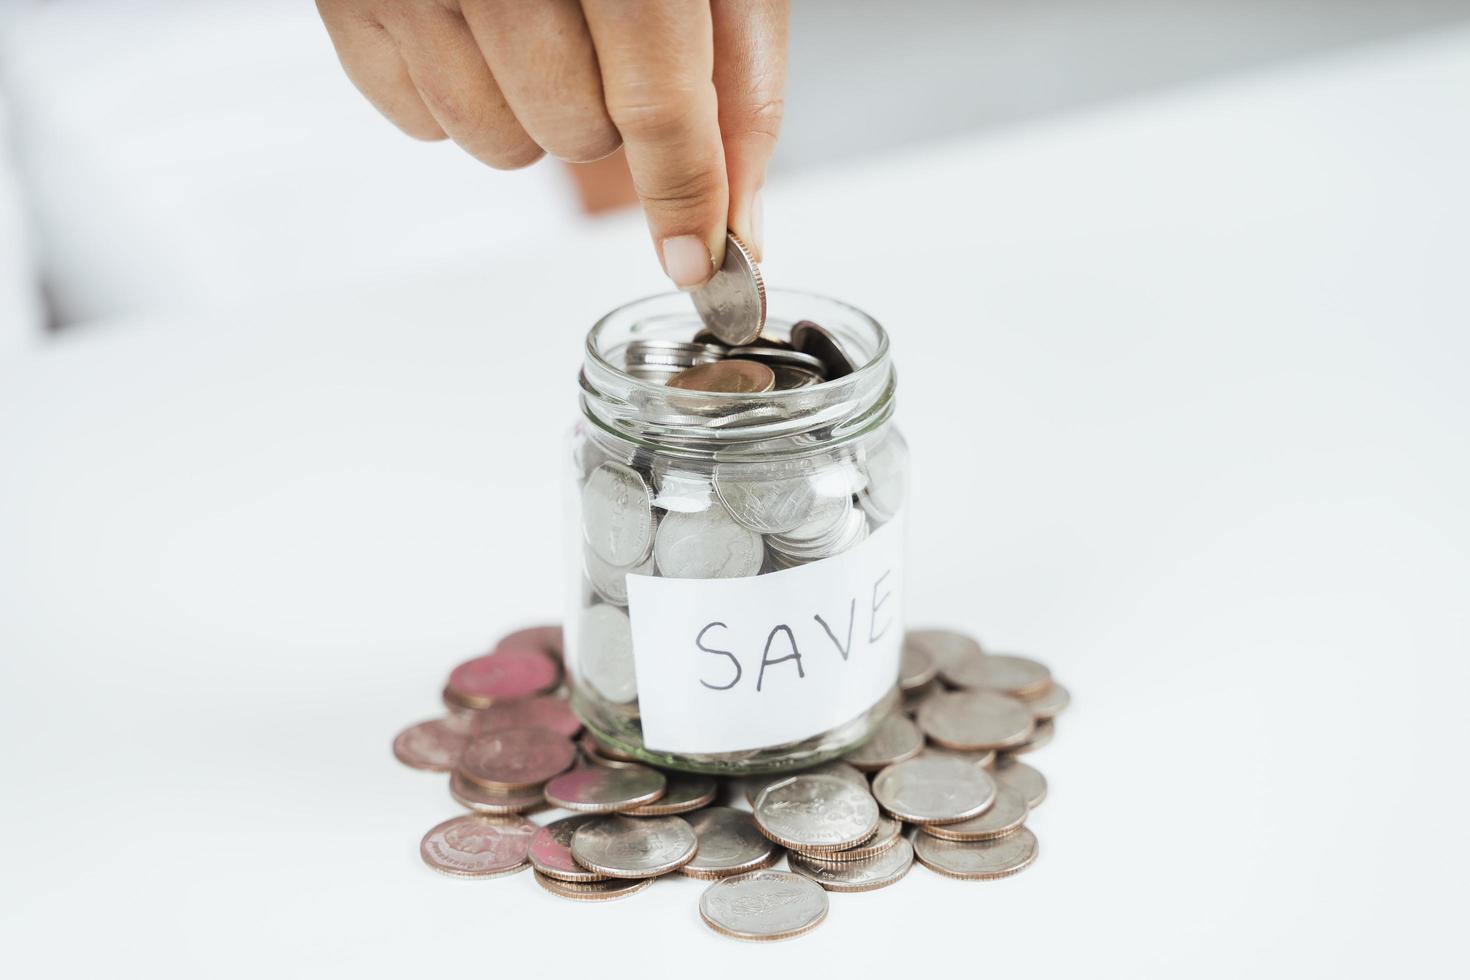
[581,289,897,458]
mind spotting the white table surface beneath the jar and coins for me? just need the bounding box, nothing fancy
[0,26,1470,977]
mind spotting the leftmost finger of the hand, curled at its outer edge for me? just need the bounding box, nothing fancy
[316,0,445,140]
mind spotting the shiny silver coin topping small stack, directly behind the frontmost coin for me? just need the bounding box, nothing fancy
[756,776,879,851]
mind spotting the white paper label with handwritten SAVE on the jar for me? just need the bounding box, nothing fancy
[628,516,904,752]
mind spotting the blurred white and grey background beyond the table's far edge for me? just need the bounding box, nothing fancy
[0,0,1470,351]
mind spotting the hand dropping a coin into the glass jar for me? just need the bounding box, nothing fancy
[316,0,788,288]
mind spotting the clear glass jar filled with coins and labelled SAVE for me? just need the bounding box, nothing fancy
[566,289,908,774]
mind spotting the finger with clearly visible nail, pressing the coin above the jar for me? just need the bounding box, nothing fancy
[582,0,729,288]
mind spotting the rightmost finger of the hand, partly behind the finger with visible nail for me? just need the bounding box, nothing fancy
[710,0,788,259]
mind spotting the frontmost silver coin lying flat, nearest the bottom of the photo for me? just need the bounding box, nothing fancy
[700,871,828,942]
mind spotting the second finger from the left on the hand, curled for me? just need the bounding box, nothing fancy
[384,3,541,170]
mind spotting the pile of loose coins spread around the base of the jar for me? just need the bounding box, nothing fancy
[392,626,1070,940]
